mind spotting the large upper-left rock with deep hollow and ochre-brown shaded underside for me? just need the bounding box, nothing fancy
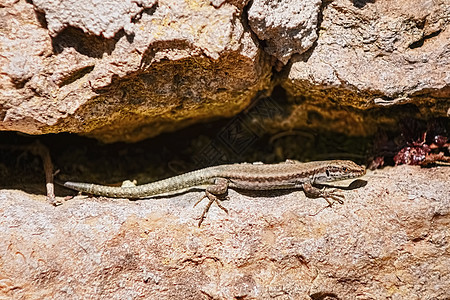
[0,0,271,142]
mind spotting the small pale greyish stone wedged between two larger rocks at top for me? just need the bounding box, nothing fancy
[248,0,322,64]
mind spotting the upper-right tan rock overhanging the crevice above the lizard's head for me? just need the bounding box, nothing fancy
[283,0,450,109]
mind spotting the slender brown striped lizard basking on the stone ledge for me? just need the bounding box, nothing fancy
[63,160,366,226]
